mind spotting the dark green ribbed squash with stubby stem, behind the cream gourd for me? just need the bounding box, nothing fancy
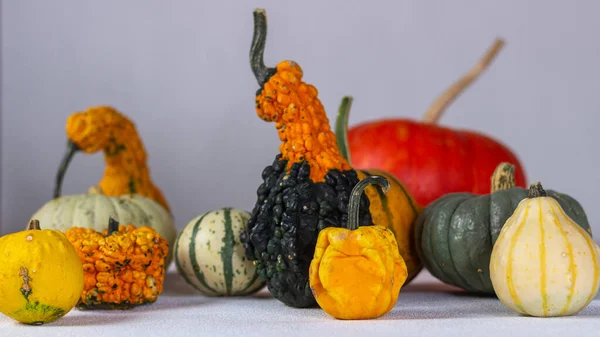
[415,163,592,295]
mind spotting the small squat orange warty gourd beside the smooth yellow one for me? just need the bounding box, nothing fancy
[66,218,168,309]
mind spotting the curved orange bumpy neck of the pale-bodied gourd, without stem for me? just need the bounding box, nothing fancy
[66,106,170,211]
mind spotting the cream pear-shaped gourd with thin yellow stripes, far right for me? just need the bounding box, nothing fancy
[490,183,600,317]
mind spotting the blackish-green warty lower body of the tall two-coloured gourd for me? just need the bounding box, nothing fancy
[240,154,372,307]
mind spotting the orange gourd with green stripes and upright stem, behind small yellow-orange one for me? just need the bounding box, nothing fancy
[336,96,422,284]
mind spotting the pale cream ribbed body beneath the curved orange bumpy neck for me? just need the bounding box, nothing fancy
[31,194,177,268]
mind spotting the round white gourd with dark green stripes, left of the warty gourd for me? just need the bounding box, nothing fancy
[175,207,265,296]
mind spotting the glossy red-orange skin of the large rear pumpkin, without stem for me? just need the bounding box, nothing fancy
[348,119,526,207]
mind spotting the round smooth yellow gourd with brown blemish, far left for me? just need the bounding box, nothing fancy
[0,220,83,325]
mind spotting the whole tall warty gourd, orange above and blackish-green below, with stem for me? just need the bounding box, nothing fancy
[240,10,373,307]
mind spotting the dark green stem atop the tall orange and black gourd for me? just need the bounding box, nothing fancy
[250,8,277,88]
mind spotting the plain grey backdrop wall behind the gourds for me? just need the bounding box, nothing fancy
[0,0,600,240]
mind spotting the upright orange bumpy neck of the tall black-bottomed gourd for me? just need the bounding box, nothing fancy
[256,61,351,182]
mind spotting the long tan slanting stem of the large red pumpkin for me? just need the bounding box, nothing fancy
[423,38,504,124]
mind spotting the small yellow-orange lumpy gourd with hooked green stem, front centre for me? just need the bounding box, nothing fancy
[309,176,408,319]
